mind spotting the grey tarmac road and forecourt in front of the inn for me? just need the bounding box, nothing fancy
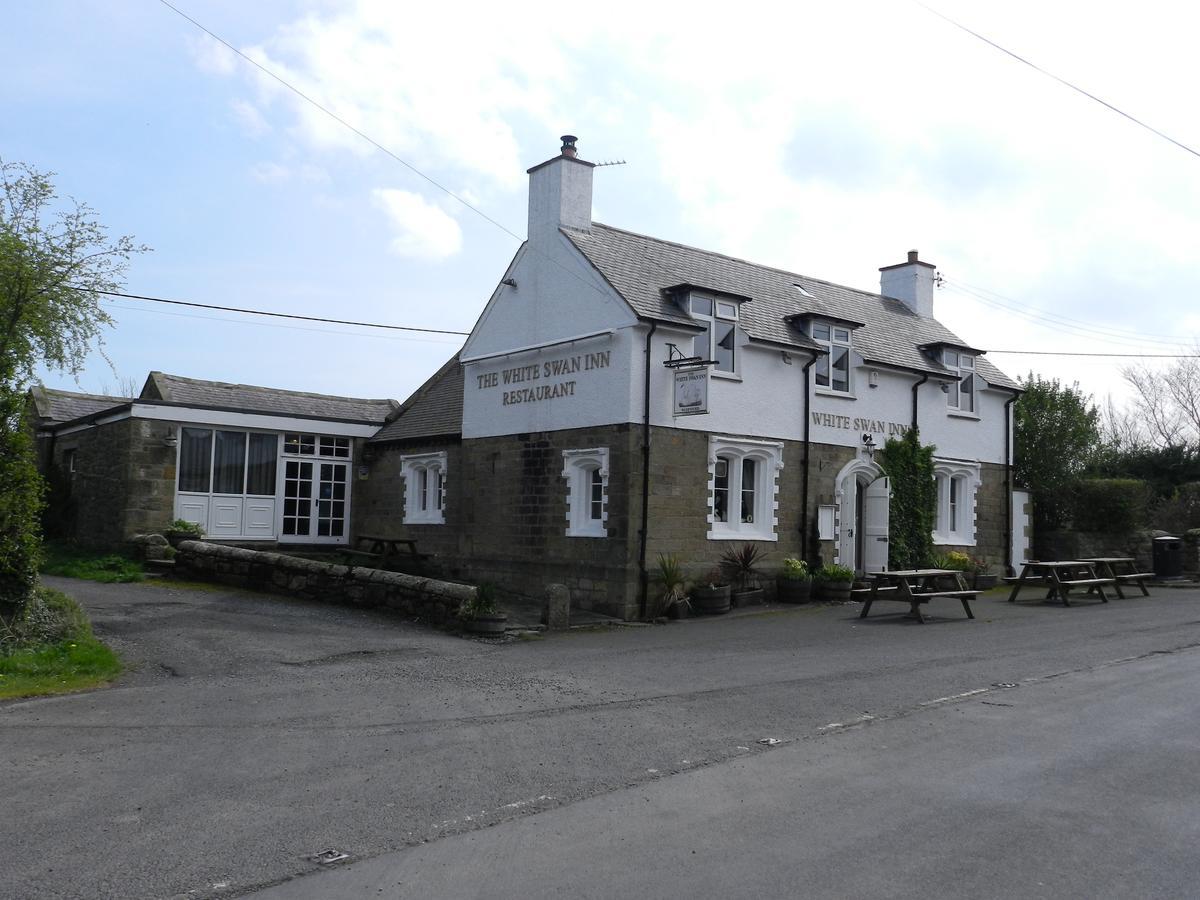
[0,580,1200,898]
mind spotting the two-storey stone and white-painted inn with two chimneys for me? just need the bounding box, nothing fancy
[355,136,1019,618]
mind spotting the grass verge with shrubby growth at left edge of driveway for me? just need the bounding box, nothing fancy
[0,587,122,700]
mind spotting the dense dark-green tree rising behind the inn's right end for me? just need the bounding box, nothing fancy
[1013,372,1100,535]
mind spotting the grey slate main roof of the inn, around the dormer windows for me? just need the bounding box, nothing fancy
[562,223,1018,389]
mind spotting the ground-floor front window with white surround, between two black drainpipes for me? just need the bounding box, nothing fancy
[708,437,784,540]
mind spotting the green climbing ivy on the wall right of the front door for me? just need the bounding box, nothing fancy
[878,428,937,569]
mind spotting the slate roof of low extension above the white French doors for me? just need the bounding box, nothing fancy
[140,372,400,425]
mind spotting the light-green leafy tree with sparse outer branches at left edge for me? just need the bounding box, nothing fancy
[0,160,145,616]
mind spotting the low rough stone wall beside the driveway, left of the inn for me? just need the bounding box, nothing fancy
[175,541,475,624]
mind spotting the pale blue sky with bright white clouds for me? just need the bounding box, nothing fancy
[0,0,1200,404]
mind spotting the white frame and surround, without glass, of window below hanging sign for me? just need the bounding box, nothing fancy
[708,434,784,541]
